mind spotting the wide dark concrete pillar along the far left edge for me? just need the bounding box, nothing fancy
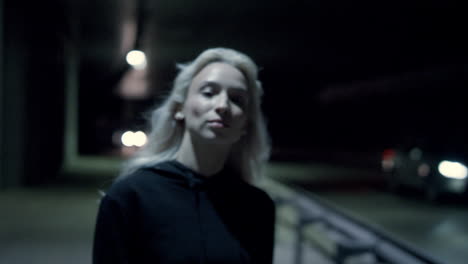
[0,0,64,189]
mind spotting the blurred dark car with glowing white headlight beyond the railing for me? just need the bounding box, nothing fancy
[382,146,468,201]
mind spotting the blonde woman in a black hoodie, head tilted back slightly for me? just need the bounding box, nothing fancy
[93,48,275,264]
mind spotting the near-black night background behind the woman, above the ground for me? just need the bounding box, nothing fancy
[0,0,468,186]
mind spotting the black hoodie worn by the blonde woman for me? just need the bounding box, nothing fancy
[93,161,275,264]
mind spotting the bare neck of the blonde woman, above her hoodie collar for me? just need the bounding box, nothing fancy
[176,133,231,177]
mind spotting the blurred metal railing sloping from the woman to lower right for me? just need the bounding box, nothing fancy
[272,182,442,264]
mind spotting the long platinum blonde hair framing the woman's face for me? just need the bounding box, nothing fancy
[118,48,270,182]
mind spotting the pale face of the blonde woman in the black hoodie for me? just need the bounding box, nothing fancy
[182,62,249,144]
